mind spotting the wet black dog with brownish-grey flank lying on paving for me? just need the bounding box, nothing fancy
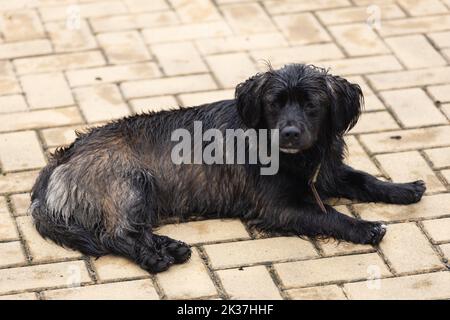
[30,64,425,273]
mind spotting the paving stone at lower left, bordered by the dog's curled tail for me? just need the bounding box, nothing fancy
[16,216,82,263]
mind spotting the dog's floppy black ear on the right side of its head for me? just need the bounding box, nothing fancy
[326,75,364,136]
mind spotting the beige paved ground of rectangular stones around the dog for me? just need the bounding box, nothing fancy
[0,0,450,299]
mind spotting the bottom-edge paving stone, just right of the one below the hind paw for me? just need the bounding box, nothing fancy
[217,266,281,300]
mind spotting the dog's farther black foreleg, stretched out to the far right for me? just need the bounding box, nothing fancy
[329,166,426,204]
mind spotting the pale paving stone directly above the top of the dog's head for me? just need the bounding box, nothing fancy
[250,43,344,68]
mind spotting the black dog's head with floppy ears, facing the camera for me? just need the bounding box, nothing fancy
[236,64,363,153]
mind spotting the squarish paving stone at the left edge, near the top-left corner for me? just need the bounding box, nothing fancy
[0,10,45,41]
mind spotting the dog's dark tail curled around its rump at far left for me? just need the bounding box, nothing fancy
[29,163,107,257]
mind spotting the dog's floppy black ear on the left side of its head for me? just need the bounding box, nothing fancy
[235,73,267,128]
